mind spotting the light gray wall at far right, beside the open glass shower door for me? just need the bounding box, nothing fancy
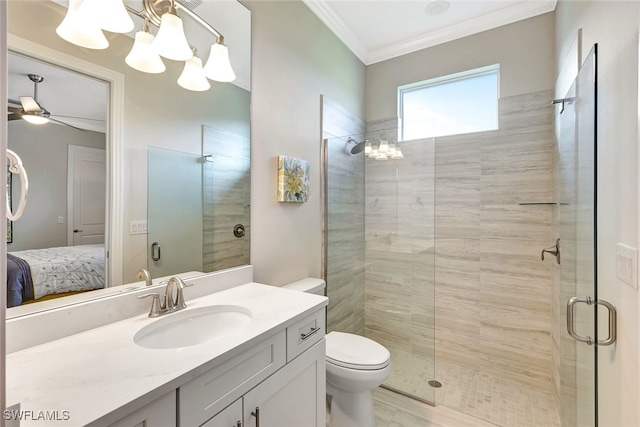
[555,1,640,427]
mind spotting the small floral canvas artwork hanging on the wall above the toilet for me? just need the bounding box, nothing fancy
[278,156,309,203]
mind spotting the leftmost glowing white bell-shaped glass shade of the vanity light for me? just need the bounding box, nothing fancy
[56,0,109,49]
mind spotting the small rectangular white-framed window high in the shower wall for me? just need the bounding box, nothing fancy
[398,64,500,141]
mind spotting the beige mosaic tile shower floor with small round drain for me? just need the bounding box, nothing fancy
[381,349,560,427]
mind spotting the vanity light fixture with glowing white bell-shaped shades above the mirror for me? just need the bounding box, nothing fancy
[56,0,236,91]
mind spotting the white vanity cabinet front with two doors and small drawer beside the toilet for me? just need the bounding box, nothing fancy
[178,308,326,427]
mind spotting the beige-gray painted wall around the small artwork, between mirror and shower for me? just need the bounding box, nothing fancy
[245,1,365,285]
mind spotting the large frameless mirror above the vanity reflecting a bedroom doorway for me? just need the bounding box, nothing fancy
[7,0,251,317]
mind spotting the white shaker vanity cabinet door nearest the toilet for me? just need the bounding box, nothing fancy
[244,339,326,427]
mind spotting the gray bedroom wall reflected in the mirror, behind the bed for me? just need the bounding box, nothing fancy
[7,120,105,251]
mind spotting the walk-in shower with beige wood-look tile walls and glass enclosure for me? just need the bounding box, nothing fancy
[322,45,595,427]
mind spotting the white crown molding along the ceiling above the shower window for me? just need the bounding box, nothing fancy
[302,0,557,65]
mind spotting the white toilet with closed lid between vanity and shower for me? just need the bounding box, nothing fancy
[284,279,391,427]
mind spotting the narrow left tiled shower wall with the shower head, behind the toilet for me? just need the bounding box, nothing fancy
[322,98,365,335]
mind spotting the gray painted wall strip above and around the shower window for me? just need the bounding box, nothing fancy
[366,13,554,122]
